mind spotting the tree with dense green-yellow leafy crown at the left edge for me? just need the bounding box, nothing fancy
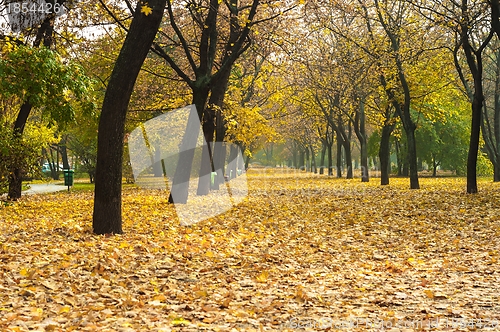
[0,46,93,199]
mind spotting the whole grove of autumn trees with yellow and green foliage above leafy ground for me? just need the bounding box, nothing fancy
[0,0,500,234]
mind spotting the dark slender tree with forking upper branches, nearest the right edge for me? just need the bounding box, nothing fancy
[414,0,499,193]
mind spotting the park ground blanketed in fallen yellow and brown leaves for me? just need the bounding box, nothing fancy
[0,170,500,331]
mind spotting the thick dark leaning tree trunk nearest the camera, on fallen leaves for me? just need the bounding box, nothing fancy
[93,0,166,234]
